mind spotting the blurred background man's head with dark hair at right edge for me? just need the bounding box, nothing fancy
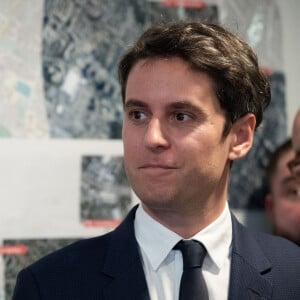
[265,139,300,246]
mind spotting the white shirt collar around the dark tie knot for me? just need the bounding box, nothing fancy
[134,203,232,271]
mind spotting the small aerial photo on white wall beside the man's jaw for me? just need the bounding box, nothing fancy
[80,156,133,226]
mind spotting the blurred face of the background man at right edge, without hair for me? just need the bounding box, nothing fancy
[267,149,300,245]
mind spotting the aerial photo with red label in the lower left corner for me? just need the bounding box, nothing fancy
[0,238,79,300]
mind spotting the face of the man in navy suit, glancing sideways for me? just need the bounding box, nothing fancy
[123,58,239,218]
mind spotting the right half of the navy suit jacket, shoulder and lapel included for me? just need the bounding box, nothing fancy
[230,217,300,300]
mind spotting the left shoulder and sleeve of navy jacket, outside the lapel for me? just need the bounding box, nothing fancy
[13,233,115,300]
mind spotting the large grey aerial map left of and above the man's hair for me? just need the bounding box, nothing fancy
[43,0,217,139]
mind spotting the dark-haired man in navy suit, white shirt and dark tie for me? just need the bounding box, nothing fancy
[13,22,300,300]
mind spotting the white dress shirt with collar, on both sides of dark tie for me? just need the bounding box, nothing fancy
[134,204,232,300]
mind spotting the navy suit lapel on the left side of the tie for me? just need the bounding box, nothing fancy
[102,207,150,300]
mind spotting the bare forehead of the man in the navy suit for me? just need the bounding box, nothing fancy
[125,57,224,115]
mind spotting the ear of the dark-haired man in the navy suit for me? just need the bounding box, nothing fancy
[228,114,256,160]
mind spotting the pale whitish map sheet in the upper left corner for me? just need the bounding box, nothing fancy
[0,0,49,139]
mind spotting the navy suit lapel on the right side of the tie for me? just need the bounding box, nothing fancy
[229,216,272,300]
